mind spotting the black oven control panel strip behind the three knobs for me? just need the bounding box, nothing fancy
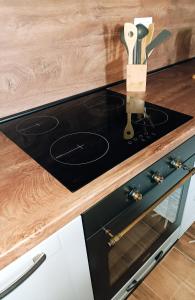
[83,137,195,238]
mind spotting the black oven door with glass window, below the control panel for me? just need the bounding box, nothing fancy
[87,185,185,300]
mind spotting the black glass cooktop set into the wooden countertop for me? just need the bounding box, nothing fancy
[0,90,192,192]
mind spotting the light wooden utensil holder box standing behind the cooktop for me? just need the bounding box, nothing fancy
[126,64,147,92]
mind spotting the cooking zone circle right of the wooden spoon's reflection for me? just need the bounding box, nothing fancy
[132,107,169,127]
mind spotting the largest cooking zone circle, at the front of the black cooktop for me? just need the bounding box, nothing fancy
[50,132,109,166]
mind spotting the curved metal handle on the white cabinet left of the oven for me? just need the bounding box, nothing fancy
[0,253,46,299]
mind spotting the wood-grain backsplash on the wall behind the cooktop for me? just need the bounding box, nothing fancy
[0,0,195,118]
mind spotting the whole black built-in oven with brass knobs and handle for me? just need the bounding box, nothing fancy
[82,137,195,300]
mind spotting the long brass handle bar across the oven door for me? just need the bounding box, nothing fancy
[105,168,195,247]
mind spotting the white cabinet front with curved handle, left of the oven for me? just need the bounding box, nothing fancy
[0,217,93,300]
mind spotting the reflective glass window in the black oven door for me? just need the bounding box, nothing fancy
[108,187,183,286]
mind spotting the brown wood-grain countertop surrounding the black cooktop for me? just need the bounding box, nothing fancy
[0,59,195,269]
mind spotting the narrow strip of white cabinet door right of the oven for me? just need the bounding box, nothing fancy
[180,170,195,235]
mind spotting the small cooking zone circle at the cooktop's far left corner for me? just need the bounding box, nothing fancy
[16,116,59,135]
